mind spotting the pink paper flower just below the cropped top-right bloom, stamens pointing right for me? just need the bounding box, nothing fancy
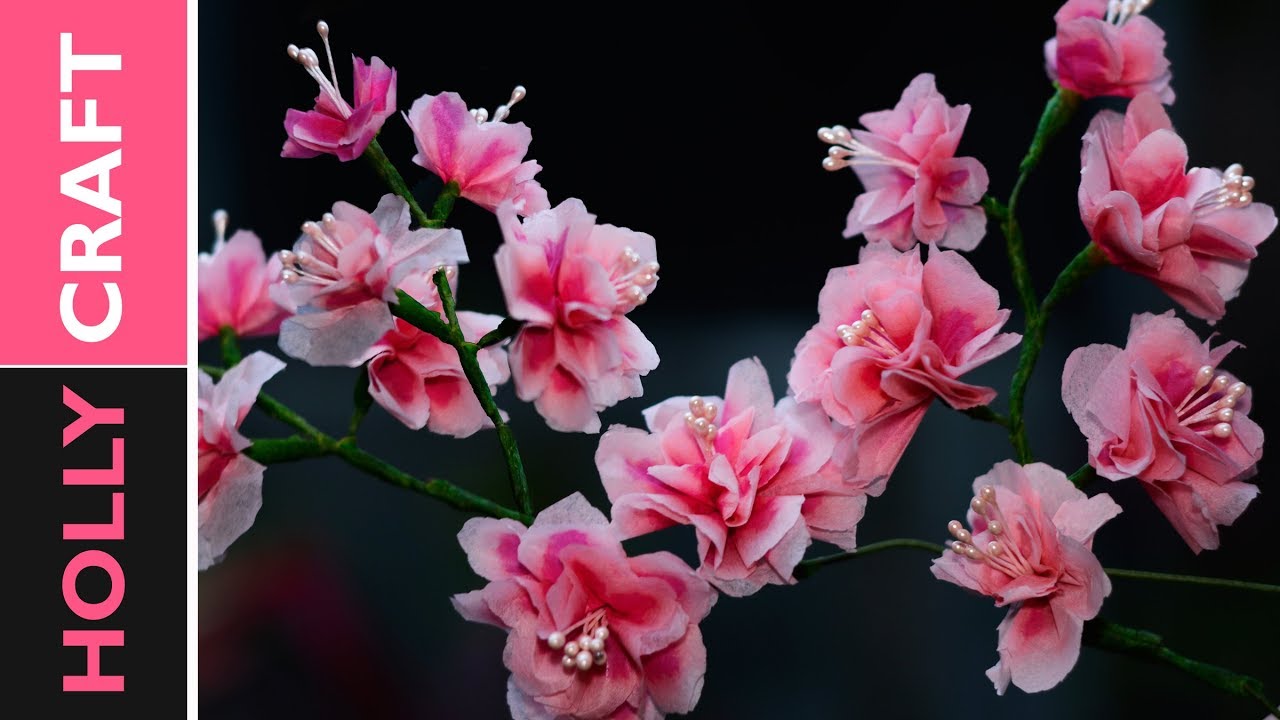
[1079,92,1276,322]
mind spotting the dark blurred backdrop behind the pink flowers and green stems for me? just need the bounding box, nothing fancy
[198,0,1280,719]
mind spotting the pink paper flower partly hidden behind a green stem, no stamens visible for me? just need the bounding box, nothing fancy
[357,305,511,437]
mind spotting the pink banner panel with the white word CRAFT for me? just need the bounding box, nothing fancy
[0,0,187,365]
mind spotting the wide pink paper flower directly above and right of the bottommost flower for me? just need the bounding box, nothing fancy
[595,357,867,597]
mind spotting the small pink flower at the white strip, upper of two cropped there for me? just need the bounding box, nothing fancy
[197,210,287,341]
